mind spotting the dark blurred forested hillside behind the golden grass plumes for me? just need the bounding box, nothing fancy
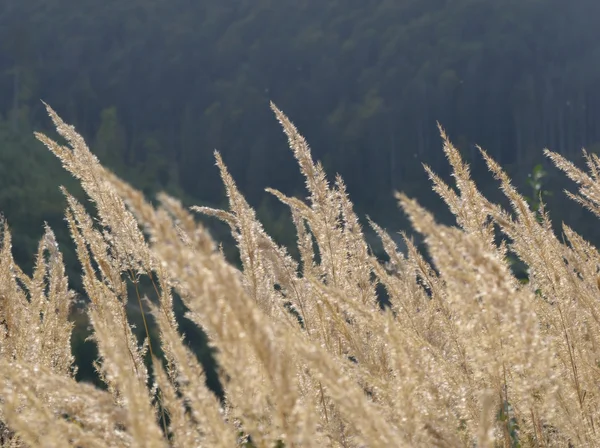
[0,0,600,382]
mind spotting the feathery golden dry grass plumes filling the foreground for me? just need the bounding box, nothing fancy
[0,106,600,448]
